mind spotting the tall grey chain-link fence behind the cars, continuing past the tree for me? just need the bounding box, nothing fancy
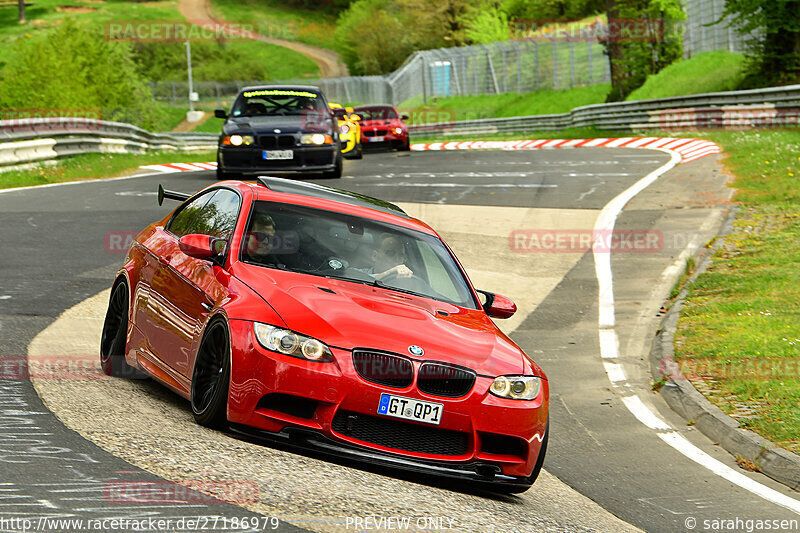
[151,0,747,107]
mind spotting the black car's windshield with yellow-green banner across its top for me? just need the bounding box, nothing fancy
[231,89,330,117]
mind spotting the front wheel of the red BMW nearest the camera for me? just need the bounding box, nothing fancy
[191,319,231,429]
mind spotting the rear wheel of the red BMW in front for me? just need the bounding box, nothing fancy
[100,280,147,379]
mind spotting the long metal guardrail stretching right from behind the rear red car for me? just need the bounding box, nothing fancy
[409,85,800,135]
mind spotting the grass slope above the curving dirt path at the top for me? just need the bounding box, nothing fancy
[211,0,336,50]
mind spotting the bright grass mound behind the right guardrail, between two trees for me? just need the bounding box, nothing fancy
[627,50,745,100]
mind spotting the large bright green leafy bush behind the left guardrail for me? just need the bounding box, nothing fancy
[0,19,158,128]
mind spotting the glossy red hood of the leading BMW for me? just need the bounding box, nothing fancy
[234,263,525,377]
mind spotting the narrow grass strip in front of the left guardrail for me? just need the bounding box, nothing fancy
[0,152,216,189]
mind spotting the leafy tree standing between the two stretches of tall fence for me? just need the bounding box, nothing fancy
[601,0,686,102]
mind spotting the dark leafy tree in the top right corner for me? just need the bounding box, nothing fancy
[720,0,800,87]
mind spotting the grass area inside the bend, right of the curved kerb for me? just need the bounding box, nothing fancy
[675,131,800,453]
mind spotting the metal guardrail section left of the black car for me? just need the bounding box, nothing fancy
[0,118,217,167]
